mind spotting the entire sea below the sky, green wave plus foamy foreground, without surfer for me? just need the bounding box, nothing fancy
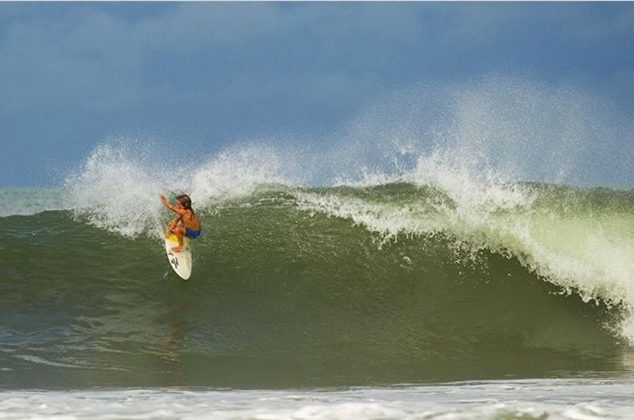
[0,147,634,419]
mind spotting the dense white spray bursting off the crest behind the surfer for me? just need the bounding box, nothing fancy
[65,139,292,236]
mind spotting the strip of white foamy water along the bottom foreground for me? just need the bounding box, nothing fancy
[0,380,634,420]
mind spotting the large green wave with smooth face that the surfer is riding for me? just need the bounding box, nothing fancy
[0,183,633,386]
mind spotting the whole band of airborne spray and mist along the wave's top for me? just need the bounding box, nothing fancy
[65,75,634,225]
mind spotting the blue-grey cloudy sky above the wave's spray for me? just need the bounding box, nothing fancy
[0,2,634,186]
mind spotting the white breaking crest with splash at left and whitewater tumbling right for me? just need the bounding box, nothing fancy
[54,138,634,342]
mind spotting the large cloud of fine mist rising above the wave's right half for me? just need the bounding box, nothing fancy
[321,75,634,188]
